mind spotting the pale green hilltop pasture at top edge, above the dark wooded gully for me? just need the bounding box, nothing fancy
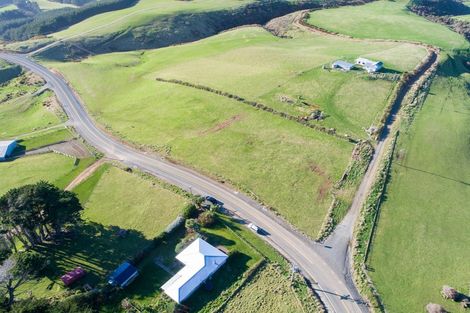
[52,0,254,39]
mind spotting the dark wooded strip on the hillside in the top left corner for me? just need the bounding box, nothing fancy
[0,0,138,41]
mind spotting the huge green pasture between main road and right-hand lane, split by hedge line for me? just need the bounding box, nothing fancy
[43,27,426,236]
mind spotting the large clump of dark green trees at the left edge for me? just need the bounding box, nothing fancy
[0,181,83,251]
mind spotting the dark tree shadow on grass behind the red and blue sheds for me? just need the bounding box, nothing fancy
[35,222,150,286]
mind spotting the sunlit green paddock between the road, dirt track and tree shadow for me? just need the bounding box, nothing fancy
[78,167,186,239]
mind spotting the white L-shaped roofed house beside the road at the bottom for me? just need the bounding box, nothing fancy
[162,238,228,303]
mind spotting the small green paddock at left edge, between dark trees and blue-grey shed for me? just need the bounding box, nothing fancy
[0,153,93,194]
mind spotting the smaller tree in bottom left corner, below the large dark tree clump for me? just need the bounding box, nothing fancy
[0,250,47,307]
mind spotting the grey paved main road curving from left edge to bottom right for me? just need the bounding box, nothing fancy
[0,52,368,313]
